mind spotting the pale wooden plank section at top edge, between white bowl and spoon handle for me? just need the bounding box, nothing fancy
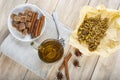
[27,0,59,14]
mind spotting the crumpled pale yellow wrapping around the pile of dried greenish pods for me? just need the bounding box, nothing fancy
[69,6,120,57]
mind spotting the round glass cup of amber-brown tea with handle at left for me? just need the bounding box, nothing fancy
[32,39,64,63]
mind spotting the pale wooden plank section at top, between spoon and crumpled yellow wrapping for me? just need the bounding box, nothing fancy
[55,0,89,29]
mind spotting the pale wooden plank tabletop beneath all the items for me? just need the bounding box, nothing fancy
[0,0,120,80]
